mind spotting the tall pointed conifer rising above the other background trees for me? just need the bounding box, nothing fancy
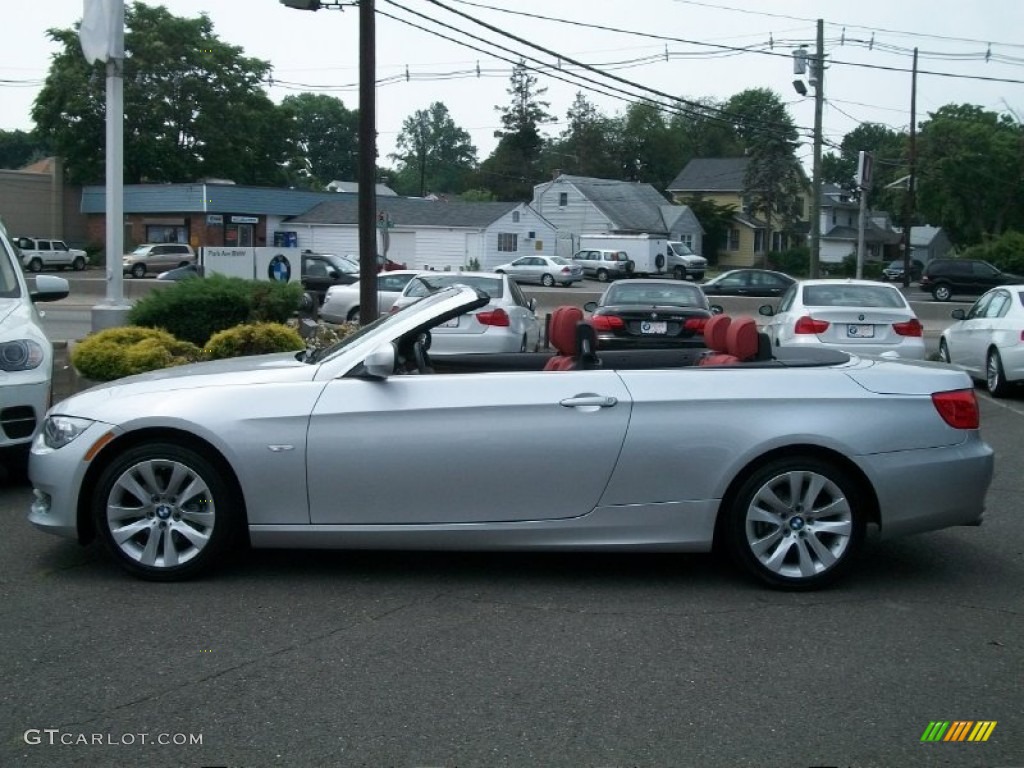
[477,61,554,201]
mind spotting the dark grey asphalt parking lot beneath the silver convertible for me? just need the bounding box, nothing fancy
[0,393,1024,768]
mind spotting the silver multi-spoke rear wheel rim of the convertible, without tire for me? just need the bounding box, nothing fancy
[744,470,853,579]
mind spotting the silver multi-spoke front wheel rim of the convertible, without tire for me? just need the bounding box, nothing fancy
[106,459,216,568]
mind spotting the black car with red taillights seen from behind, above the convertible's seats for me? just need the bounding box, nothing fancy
[584,280,712,349]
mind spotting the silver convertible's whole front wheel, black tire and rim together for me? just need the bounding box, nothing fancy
[92,442,244,582]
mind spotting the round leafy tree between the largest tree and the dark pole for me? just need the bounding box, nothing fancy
[280,93,359,189]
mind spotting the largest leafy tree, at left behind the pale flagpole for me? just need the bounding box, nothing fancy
[32,2,288,183]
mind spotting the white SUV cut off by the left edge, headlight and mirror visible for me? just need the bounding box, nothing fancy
[0,227,69,462]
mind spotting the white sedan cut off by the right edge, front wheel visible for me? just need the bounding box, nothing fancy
[939,285,1024,397]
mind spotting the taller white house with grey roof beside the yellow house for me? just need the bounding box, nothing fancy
[532,173,703,256]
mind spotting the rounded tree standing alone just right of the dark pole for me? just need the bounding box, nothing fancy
[391,101,476,197]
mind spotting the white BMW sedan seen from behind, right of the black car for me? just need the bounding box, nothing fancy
[760,280,925,360]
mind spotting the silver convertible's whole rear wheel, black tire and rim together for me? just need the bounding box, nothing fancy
[720,456,867,590]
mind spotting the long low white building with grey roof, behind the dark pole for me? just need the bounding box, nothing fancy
[282,197,555,270]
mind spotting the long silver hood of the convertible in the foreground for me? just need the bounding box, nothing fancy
[53,352,316,416]
